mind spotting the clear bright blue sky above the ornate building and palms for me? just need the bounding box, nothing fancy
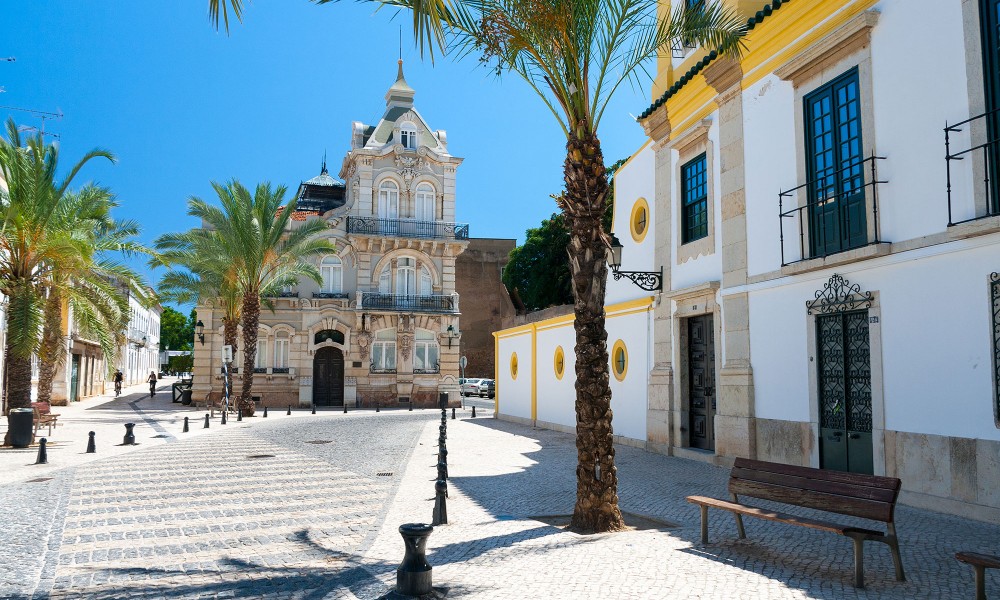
[0,0,649,296]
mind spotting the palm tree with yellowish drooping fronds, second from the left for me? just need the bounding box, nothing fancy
[38,185,148,402]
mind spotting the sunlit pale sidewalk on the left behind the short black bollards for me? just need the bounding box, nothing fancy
[0,377,225,485]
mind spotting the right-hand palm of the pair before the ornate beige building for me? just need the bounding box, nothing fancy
[170,179,335,415]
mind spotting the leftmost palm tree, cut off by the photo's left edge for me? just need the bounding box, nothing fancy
[0,120,114,420]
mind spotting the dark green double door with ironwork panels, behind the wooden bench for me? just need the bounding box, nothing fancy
[816,310,874,474]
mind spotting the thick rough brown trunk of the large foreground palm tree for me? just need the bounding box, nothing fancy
[561,127,624,532]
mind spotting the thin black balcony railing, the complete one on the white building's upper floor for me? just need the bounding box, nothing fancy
[778,154,889,267]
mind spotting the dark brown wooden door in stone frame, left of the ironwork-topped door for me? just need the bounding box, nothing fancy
[687,315,715,450]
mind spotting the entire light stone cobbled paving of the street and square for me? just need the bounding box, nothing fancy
[0,386,1000,599]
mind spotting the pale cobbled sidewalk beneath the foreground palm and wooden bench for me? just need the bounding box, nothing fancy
[352,419,1000,599]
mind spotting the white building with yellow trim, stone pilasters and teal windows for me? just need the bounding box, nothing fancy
[497,0,1000,520]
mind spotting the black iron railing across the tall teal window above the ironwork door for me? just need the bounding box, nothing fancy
[778,152,889,267]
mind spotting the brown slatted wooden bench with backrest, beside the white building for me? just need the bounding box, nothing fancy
[687,458,906,588]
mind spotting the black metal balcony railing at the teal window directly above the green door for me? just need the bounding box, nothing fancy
[778,153,889,267]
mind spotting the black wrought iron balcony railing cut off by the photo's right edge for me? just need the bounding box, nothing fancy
[944,109,1000,227]
